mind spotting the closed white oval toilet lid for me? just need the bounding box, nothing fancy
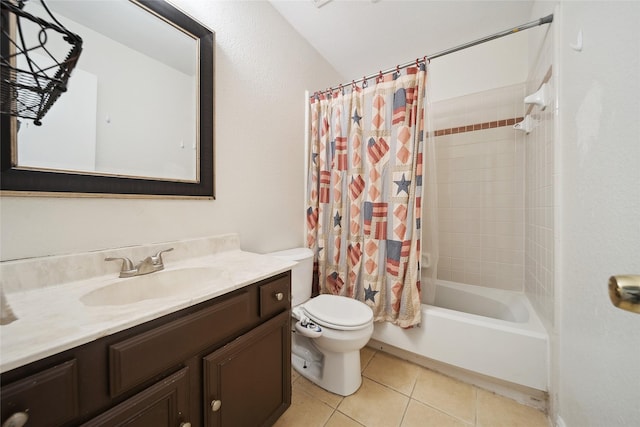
[304,294,373,330]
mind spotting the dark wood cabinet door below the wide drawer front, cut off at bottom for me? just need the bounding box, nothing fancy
[83,368,189,427]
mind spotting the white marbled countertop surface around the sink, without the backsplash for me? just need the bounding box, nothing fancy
[0,250,295,372]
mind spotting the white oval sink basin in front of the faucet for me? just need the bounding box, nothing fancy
[80,267,228,306]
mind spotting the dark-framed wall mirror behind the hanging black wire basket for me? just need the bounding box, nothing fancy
[0,0,214,198]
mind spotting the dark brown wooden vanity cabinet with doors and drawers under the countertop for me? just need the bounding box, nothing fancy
[0,236,291,427]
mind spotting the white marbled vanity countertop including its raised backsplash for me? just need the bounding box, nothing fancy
[0,234,294,372]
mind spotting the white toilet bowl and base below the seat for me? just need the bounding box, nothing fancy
[291,333,362,396]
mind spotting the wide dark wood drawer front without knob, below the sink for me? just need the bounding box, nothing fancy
[109,292,252,397]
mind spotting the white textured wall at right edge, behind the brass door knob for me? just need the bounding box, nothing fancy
[554,1,640,427]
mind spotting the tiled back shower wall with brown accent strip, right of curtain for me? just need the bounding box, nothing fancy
[425,84,526,291]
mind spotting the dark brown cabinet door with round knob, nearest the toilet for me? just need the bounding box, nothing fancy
[203,311,291,427]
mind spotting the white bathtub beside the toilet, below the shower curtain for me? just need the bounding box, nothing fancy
[372,280,548,391]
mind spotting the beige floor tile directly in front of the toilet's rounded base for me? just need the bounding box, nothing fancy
[338,378,409,427]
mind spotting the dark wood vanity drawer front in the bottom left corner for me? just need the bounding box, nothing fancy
[2,359,79,426]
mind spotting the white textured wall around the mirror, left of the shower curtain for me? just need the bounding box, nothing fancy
[0,0,344,260]
